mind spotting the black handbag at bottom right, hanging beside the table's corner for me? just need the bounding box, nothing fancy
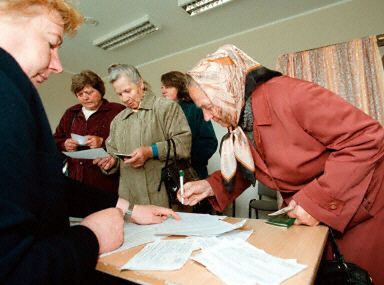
[315,228,373,285]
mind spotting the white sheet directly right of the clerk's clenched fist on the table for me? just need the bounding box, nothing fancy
[101,223,165,257]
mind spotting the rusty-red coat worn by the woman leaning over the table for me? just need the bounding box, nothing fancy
[207,76,384,284]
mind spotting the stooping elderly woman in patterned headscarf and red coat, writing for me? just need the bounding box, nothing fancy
[178,45,384,284]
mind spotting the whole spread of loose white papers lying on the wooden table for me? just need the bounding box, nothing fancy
[110,213,306,285]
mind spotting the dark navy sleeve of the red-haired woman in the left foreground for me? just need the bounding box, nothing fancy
[0,73,102,284]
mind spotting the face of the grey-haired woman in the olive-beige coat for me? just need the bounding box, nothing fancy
[112,75,144,109]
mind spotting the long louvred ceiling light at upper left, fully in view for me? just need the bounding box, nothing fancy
[93,15,159,50]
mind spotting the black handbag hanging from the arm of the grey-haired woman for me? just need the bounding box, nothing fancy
[157,139,199,207]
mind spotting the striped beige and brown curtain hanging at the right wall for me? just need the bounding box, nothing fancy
[276,36,384,125]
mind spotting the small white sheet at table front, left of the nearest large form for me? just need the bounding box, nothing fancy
[121,239,193,271]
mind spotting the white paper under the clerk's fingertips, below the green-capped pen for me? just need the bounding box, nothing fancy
[157,213,246,236]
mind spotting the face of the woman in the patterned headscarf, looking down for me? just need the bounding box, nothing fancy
[188,82,231,128]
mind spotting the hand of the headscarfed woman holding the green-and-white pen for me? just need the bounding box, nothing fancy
[177,180,215,206]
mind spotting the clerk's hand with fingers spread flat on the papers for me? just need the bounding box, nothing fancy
[131,205,180,225]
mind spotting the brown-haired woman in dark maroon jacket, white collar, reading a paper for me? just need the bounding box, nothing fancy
[54,70,125,193]
